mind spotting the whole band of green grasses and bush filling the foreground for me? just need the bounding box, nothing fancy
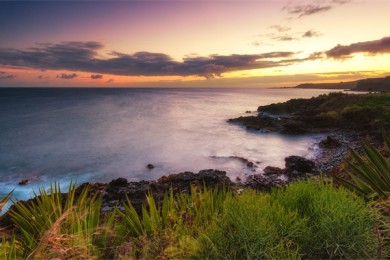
[0,182,376,259]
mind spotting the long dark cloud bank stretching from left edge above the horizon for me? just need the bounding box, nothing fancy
[0,42,308,79]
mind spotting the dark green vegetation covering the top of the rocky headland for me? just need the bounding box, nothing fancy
[258,93,390,131]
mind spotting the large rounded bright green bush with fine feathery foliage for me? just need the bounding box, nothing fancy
[197,182,376,259]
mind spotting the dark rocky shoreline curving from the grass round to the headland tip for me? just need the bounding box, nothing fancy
[0,94,382,234]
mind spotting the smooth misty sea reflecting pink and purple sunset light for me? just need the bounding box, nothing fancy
[0,89,336,209]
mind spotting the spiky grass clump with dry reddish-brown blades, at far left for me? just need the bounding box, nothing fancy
[10,183,114,258]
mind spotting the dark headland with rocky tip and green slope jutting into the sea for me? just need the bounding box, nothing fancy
[229,93,390,134]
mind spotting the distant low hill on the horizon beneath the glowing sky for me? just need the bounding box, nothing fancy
[295,76,390,92]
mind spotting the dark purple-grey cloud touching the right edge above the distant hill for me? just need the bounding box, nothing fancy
[325,37,390,59]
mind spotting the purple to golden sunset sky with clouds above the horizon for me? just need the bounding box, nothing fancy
[0,0,390,88]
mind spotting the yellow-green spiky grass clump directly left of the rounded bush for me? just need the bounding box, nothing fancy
[118,186,231,258]
